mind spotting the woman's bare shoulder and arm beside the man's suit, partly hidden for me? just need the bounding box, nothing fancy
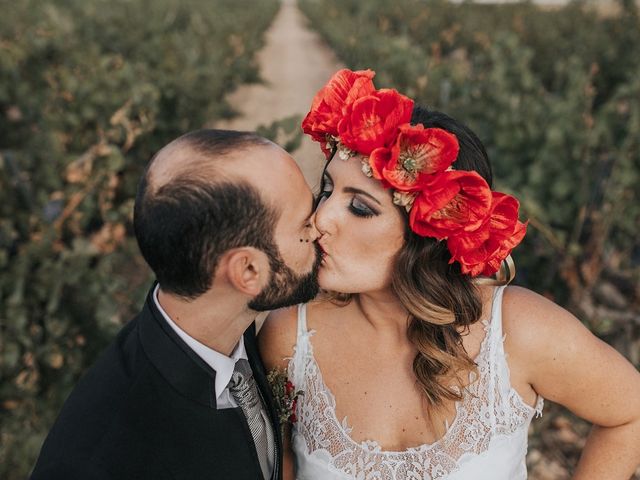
[258,308,297,480]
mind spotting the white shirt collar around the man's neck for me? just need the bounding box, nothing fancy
[153,285,248,401]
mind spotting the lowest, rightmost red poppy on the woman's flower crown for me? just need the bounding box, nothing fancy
[447,192,527,276]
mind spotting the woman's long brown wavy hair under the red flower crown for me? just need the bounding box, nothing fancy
[398,106,493,411]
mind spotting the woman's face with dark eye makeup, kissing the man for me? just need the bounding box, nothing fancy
[315,156,406,293]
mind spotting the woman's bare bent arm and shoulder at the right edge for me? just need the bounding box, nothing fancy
[503,288,640,480]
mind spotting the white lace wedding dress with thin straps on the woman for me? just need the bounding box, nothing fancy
[289,287,543,480]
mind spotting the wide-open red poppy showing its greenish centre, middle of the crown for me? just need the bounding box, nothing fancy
[372,124,460,191]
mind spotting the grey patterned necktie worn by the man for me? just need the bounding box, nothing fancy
[229,359,275,479]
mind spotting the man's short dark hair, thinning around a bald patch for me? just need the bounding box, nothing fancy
[133,130,279,299]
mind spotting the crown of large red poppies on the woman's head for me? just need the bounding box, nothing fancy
[302,69,527,277]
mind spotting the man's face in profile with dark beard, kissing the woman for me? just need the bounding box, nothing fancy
[249,145,322,311]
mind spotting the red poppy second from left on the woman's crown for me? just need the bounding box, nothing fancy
[338,89,413,156]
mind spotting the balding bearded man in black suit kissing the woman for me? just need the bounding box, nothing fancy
[32,130,320,480]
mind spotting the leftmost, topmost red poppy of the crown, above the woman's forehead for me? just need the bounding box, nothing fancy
[302,68,375,153]
